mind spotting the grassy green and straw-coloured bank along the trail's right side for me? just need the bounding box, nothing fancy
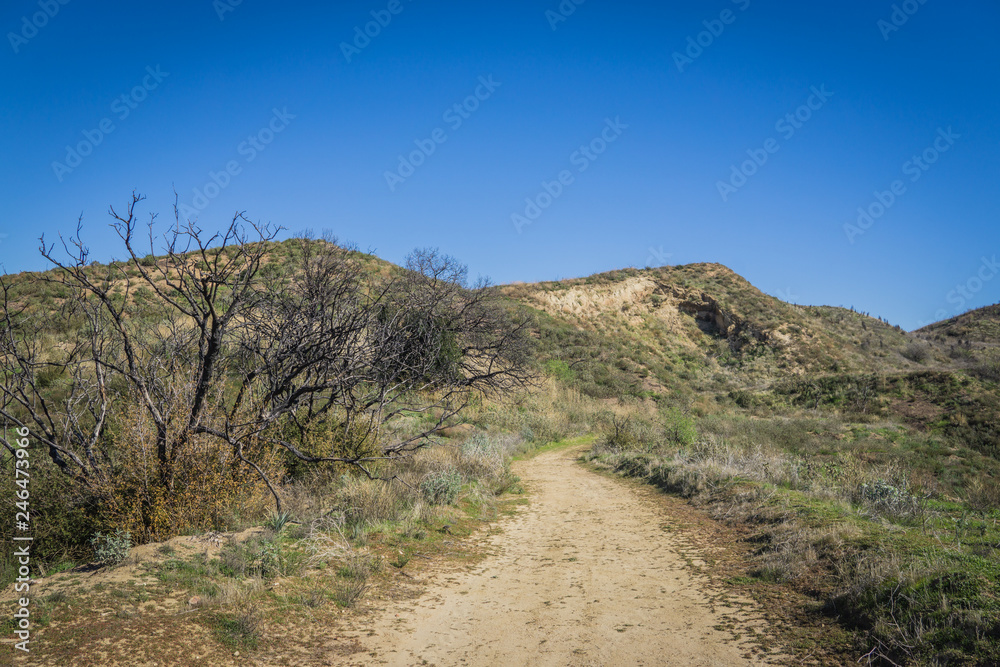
[589,396,1000,665]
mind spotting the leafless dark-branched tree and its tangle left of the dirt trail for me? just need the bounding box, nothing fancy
[0,194,531,511]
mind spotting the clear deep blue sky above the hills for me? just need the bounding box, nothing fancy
[0,0,1000,329]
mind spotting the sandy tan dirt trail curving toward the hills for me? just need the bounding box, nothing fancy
[355,450,776,666]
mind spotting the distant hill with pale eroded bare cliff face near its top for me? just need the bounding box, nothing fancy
[504,264,932,395]
